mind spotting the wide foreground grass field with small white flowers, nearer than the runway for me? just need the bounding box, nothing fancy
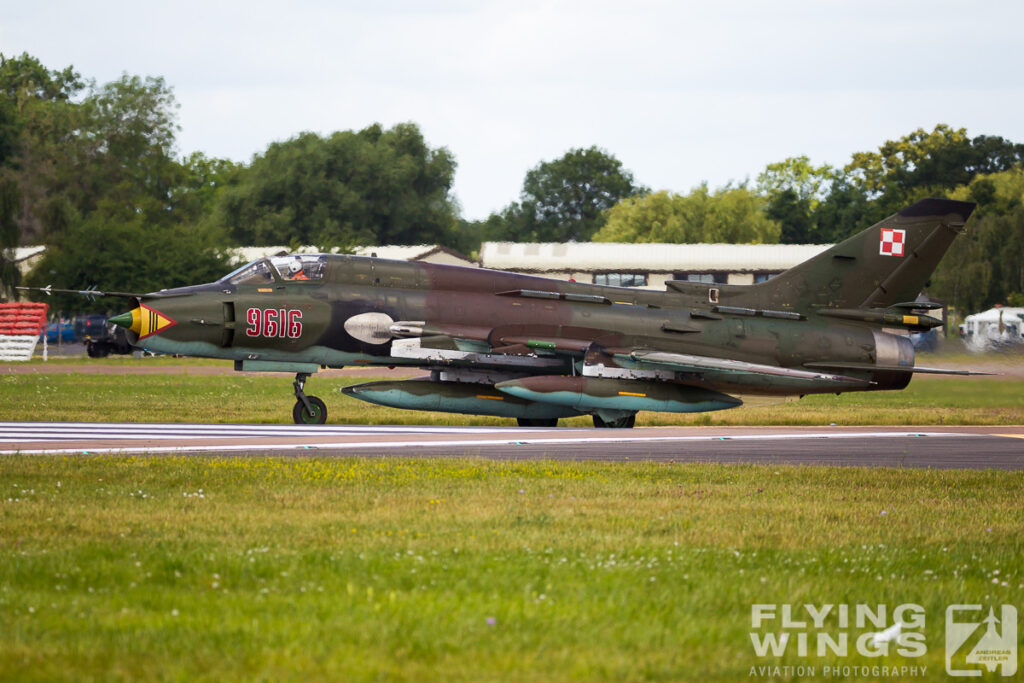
[0,457,1024,681]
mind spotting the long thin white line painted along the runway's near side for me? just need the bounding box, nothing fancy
[0,430,984,455]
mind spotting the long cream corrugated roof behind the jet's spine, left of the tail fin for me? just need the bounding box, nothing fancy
[480,242,831,272]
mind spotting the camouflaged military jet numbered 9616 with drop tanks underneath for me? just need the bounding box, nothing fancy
[19,194,974,427]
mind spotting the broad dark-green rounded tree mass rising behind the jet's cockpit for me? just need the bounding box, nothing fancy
[215,123,457,247]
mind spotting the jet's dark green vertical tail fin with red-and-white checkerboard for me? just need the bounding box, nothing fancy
[755,199,975,310]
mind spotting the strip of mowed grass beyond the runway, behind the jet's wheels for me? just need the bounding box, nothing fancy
[0,367,1024,426]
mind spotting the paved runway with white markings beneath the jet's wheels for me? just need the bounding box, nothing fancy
[0,422,1024,470]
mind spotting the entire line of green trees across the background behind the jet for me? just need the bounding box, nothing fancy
[0,54,1024,311]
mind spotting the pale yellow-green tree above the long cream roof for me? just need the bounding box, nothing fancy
[594,183,780,244]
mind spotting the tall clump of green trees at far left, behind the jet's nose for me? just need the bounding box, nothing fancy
[0,55,233,310]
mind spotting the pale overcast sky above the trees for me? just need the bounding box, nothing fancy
[8,0,1024,218]
